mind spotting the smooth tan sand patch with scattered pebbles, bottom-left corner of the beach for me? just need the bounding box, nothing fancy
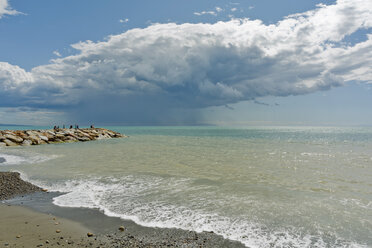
[0,204,104,247]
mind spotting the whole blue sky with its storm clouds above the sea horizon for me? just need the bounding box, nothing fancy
[0,0,372,126]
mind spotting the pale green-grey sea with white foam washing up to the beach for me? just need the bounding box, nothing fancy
[0,126,372,247]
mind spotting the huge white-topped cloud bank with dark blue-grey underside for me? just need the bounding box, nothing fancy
[0,0,372,121]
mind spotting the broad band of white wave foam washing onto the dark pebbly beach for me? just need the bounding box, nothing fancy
[24,176,367,248]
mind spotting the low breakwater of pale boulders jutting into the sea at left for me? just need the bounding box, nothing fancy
[0,128,127,147]
